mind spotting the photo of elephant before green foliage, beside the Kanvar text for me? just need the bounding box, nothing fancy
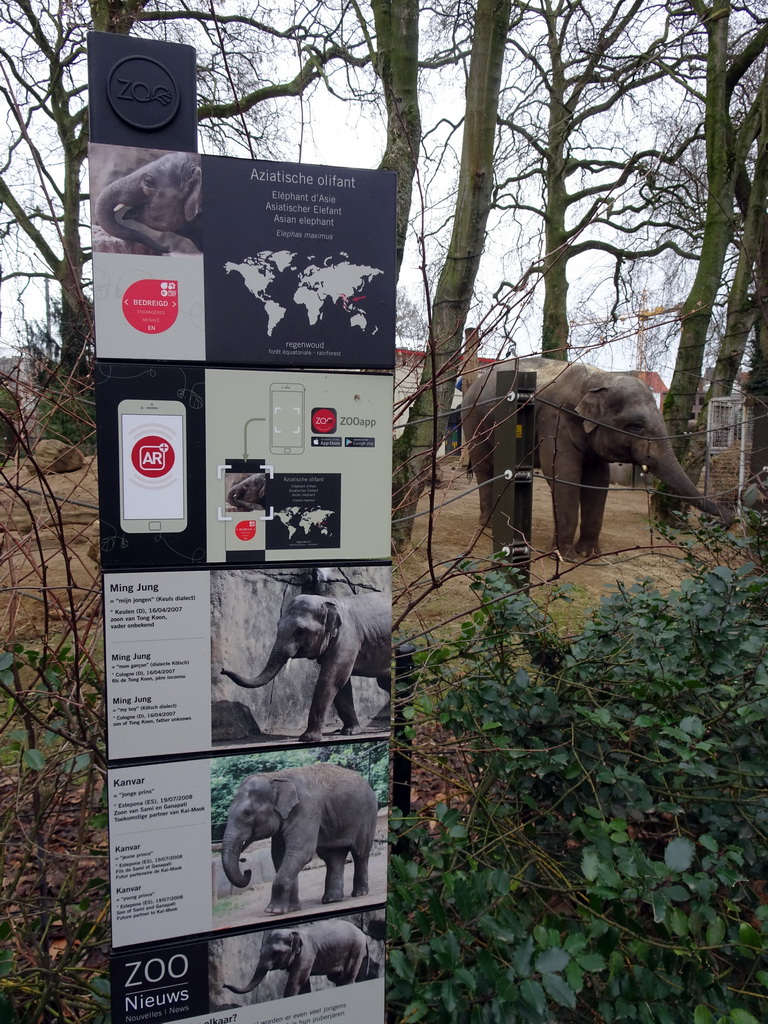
[211,741,388,928]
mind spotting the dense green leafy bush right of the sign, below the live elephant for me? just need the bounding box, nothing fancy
[389,565,768,1024]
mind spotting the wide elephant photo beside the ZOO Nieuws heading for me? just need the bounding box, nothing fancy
[208,910,385,1011]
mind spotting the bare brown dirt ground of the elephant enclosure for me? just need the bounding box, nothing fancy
[0,457,704,639]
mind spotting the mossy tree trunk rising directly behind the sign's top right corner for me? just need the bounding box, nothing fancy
[372,0,421,274]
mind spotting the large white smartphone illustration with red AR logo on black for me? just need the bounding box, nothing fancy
[118,399,186,534]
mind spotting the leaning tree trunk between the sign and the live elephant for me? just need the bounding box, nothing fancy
[393,0,511,548]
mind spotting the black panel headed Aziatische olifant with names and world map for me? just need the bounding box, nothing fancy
[202,157,396,369]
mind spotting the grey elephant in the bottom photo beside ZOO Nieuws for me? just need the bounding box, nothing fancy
[224,921,368,997]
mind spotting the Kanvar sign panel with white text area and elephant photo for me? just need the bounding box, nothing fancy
[109,739,388,946]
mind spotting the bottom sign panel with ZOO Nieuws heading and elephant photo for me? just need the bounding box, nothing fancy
[112,907,386,1024]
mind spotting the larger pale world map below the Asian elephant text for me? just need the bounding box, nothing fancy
[224,249,384,338]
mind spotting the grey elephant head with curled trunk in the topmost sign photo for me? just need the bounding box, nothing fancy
[95,153,203,253]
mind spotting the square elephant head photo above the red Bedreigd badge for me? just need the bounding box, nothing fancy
[90,145,203,256]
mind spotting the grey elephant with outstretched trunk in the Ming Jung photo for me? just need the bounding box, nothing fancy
[221,594,392,742]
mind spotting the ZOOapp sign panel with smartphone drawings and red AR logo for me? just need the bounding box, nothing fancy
[95,361,392,569]
